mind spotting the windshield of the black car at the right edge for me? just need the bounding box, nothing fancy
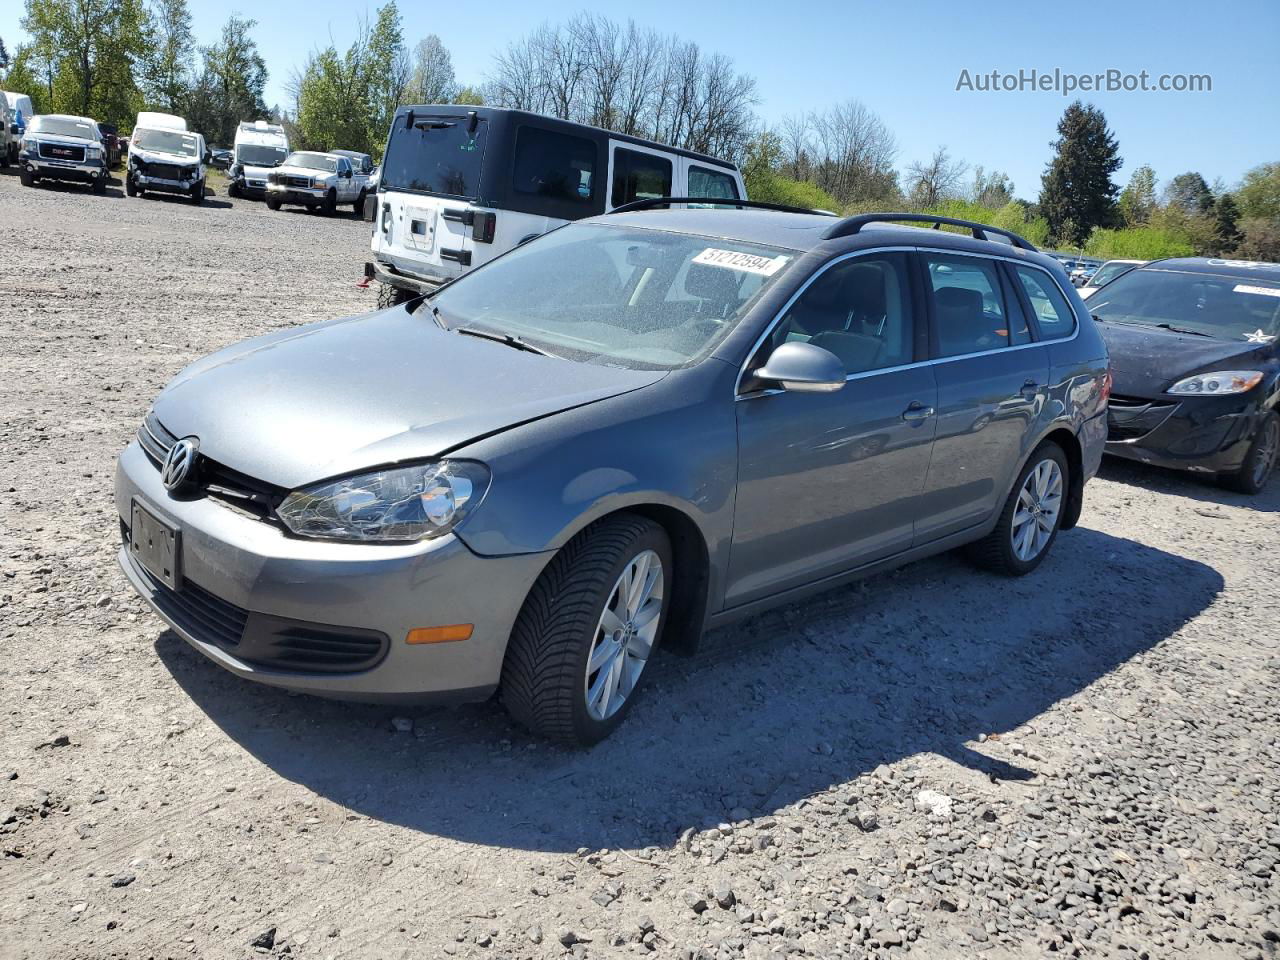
[1089,270,1280,343]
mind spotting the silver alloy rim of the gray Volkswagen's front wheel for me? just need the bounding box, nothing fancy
[584,550,664,721]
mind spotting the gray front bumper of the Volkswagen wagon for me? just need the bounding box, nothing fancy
[115,442,548,701]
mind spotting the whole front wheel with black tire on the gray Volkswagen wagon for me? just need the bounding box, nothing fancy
[500,513,676,746]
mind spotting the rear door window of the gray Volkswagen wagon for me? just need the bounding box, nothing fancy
[924,253,1010,357]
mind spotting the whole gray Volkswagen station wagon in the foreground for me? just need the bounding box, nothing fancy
[115,207,1110,744]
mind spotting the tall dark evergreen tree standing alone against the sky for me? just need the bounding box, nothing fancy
[1039,100,1120,247]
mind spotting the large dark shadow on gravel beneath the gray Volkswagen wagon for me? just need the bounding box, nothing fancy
[156,529,1222,851]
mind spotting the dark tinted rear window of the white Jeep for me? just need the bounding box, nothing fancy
[381,115,489,200]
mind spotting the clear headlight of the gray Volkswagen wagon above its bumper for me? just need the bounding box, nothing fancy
[276,460,489,543]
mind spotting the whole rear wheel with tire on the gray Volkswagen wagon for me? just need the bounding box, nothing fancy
[969,442,1071,576]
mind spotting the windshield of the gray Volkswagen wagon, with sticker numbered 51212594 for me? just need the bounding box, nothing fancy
[431,224,799,370]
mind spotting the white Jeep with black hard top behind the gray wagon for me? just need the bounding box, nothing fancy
[365,105,746,306]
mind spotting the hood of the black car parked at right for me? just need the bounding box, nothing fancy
[1098,321,1275,397]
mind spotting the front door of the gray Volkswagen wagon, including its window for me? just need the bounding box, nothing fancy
[726,251,937,607]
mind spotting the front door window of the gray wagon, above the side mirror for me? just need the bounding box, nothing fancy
[760,253,915,374]
